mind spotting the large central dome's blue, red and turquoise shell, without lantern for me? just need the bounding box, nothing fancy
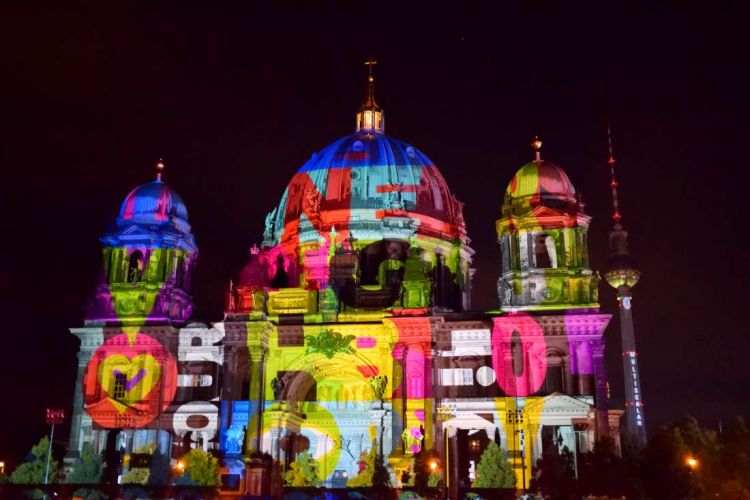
[273,130,464,247]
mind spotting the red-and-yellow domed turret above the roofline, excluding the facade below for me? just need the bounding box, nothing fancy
[496,145,599,311]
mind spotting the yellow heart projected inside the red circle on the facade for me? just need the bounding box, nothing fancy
[99,354,161,413]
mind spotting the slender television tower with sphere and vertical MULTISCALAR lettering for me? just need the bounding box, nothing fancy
[604,127,646,446]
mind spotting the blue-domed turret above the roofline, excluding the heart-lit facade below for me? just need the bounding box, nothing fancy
[86,160,198,325]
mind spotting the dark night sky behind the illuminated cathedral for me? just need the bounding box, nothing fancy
[0,2,750,461]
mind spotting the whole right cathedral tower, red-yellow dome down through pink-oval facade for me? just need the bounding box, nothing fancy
[491,138,610,487]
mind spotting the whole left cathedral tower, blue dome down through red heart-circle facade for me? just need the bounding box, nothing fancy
[66,161,201,472]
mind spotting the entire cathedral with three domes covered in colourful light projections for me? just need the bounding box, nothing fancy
[68,66,644,494]
